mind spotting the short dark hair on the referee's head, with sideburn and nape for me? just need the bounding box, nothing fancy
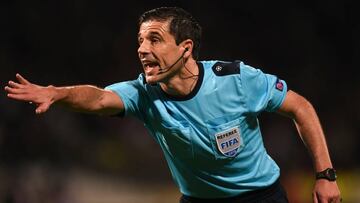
[139,7,201,60]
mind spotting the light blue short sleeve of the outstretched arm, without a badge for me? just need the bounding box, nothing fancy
[105,75,145,120]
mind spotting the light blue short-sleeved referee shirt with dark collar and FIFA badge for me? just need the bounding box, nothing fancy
[106,61,287,198]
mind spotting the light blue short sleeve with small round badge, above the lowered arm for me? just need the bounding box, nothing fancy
[240,62,287,114]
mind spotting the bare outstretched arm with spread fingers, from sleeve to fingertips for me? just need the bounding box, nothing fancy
[5,74,124,115]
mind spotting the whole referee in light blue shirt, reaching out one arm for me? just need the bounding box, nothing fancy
[5,7,340,203]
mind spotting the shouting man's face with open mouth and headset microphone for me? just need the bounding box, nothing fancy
[138,20,183,84]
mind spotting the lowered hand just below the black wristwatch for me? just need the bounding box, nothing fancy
[313,179,342,203]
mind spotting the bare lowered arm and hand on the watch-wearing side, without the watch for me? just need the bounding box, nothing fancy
[278,90,340,203]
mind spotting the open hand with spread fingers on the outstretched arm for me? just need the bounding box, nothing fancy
[5,74,55,114]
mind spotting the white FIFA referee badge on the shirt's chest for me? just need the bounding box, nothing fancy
[215,127,242,157]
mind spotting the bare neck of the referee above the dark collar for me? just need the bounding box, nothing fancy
[160,59,199,96]
